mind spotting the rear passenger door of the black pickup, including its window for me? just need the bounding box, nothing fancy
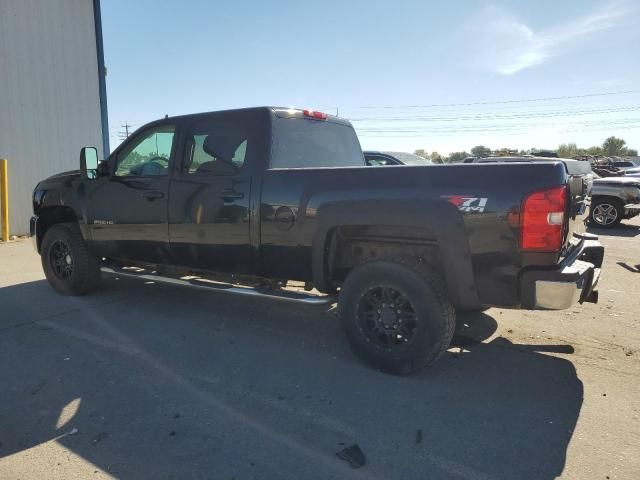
[169,114,255,273]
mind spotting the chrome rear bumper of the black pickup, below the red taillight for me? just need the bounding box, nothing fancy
[520,234,604,310]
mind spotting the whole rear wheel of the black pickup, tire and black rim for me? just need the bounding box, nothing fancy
[338,257,456,374]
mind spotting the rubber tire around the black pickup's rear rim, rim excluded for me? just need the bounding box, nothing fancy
[338,257,456,375]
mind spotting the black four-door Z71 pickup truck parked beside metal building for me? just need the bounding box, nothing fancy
[31,107,603,373]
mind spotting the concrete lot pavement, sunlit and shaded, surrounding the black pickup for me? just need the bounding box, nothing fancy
[0,221,640,480]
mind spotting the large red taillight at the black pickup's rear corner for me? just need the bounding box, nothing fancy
[520,186,567,252]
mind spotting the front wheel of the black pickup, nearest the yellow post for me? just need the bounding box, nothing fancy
[41,223,100,295]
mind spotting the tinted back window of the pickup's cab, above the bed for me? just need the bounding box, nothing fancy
[270,118,365,168]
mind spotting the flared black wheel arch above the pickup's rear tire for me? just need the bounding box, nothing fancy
[312,199,480,308]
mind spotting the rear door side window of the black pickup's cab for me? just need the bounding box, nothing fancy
[183,121,249,175]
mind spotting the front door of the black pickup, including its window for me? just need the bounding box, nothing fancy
[87,124,175,263]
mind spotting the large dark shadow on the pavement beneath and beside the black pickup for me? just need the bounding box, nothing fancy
[0,280,583,479]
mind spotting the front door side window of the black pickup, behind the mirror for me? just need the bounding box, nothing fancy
[115,125,175,177]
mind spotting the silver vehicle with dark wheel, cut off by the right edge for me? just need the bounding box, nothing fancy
[589,175,640,228]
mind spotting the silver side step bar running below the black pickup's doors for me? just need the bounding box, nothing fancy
[100,267,337,305]
